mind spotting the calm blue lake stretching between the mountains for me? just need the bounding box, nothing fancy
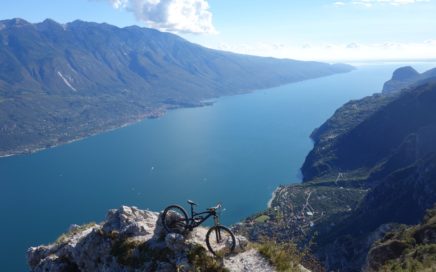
[0,63,436,271]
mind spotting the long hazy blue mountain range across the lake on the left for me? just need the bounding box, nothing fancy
[0,19,352,156]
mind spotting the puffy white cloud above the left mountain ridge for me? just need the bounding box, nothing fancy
[101,0,216,34]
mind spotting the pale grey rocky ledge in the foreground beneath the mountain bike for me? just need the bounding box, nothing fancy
[27,206,307,272]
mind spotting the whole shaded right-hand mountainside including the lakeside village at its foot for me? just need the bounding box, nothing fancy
[240,66,436,271]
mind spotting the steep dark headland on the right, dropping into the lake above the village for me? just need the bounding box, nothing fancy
[301,67,436,184]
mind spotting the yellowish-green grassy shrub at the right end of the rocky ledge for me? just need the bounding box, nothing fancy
[256,241,304,272]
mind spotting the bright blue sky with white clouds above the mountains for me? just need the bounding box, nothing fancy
[0,0,436,62]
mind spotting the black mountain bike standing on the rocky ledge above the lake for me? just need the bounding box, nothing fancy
[162,200,236,256]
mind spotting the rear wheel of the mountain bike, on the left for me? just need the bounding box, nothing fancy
[162,205,188,233]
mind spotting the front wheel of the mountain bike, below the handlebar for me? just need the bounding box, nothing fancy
[206,225,236,257]
